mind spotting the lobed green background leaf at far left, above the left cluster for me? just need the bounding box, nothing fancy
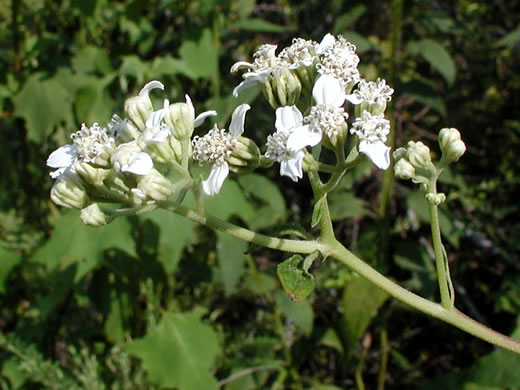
[13,72,75,143]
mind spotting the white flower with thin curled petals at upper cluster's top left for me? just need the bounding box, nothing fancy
[231,44,299,97]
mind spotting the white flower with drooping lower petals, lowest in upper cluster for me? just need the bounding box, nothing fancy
[265,106,305,181]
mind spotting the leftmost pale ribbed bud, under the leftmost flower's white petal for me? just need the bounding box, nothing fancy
[51,172,88,209]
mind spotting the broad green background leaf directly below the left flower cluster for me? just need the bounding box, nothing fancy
[30,210,136,281]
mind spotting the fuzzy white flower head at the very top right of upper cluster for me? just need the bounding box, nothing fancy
[316,34,360,86]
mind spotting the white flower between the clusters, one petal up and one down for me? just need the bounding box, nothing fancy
[192,104,251,195]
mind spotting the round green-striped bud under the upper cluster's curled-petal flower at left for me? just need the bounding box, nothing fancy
[263,69,302,108]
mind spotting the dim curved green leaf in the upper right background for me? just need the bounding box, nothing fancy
[407,39,456,85]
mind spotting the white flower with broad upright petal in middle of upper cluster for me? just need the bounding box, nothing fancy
[287,75,348,150]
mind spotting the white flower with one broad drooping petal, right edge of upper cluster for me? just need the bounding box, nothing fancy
[350,111,390,169]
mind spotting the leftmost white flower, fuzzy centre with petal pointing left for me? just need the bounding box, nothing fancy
[47,123,115,179]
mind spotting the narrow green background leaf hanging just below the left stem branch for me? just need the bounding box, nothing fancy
[217,232,247,296]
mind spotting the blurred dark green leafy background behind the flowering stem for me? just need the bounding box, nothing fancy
[0,0,520,390]
